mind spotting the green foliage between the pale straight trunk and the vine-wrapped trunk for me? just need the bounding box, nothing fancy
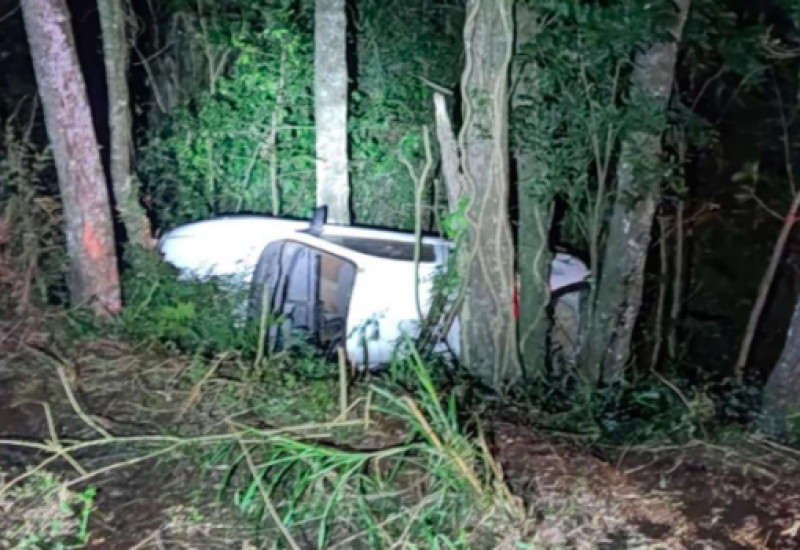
[350,0,463,229]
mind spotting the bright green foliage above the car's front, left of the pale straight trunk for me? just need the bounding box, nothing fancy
[139,1,314,225]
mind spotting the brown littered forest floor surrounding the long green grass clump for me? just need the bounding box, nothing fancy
[0,313,800,550]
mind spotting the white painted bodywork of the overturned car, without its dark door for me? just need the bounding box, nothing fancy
[159,216,588,367]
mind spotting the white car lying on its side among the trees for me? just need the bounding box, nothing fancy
[158,208,589,368]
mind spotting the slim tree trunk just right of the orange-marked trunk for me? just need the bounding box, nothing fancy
[97,0,151,248]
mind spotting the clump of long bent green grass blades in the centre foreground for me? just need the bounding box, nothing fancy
[209,354,521,549]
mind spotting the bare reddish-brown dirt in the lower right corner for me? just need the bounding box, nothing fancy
[495,424,800,550]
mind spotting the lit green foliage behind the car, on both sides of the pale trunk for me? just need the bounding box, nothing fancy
[139,1,461,228]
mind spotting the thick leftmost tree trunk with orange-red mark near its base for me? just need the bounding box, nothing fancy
[21,0,121,313]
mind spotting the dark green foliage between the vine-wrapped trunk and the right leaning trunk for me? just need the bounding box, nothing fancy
[511,1,674,246]
